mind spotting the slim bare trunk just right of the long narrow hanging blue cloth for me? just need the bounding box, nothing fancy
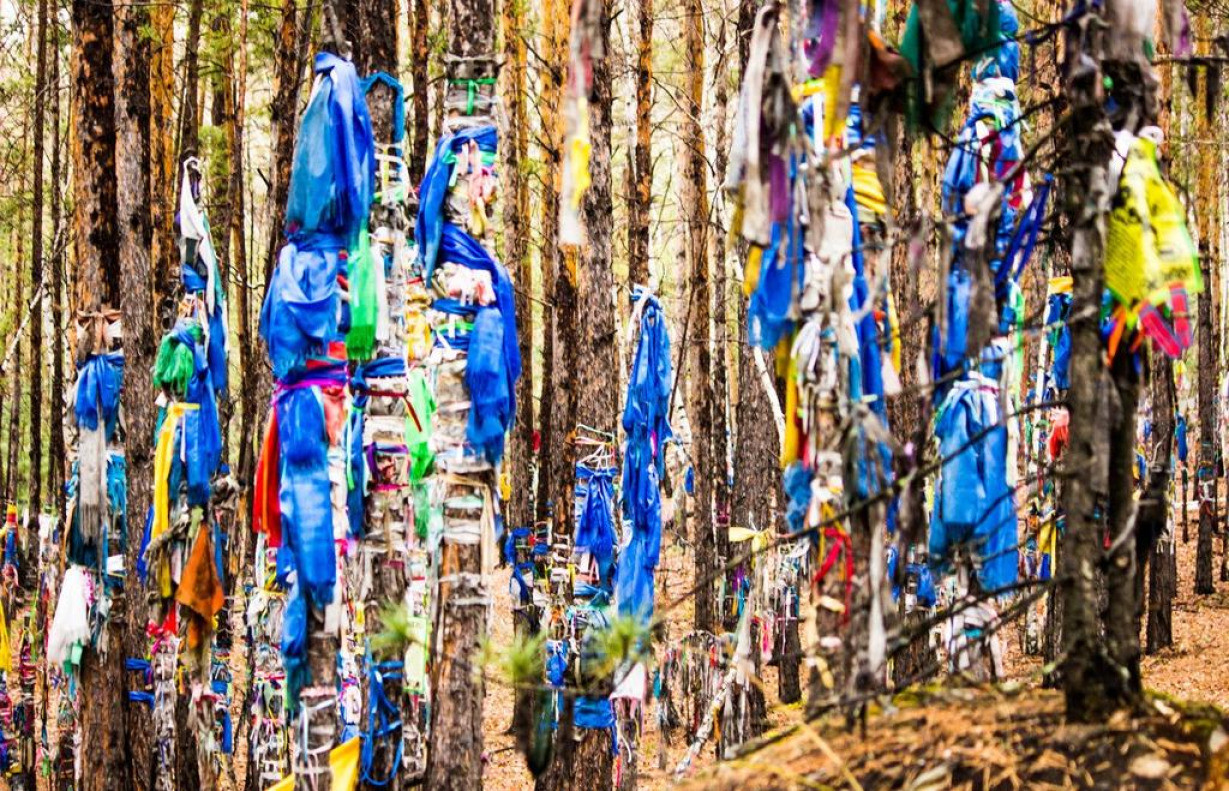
[680,0,719,631]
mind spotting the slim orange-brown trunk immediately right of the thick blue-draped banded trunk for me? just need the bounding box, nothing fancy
[501,2,535,528]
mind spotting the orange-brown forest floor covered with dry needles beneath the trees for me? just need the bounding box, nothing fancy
[483,509,1229,791]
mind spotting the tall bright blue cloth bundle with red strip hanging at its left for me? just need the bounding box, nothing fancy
[253,47,373,717]
